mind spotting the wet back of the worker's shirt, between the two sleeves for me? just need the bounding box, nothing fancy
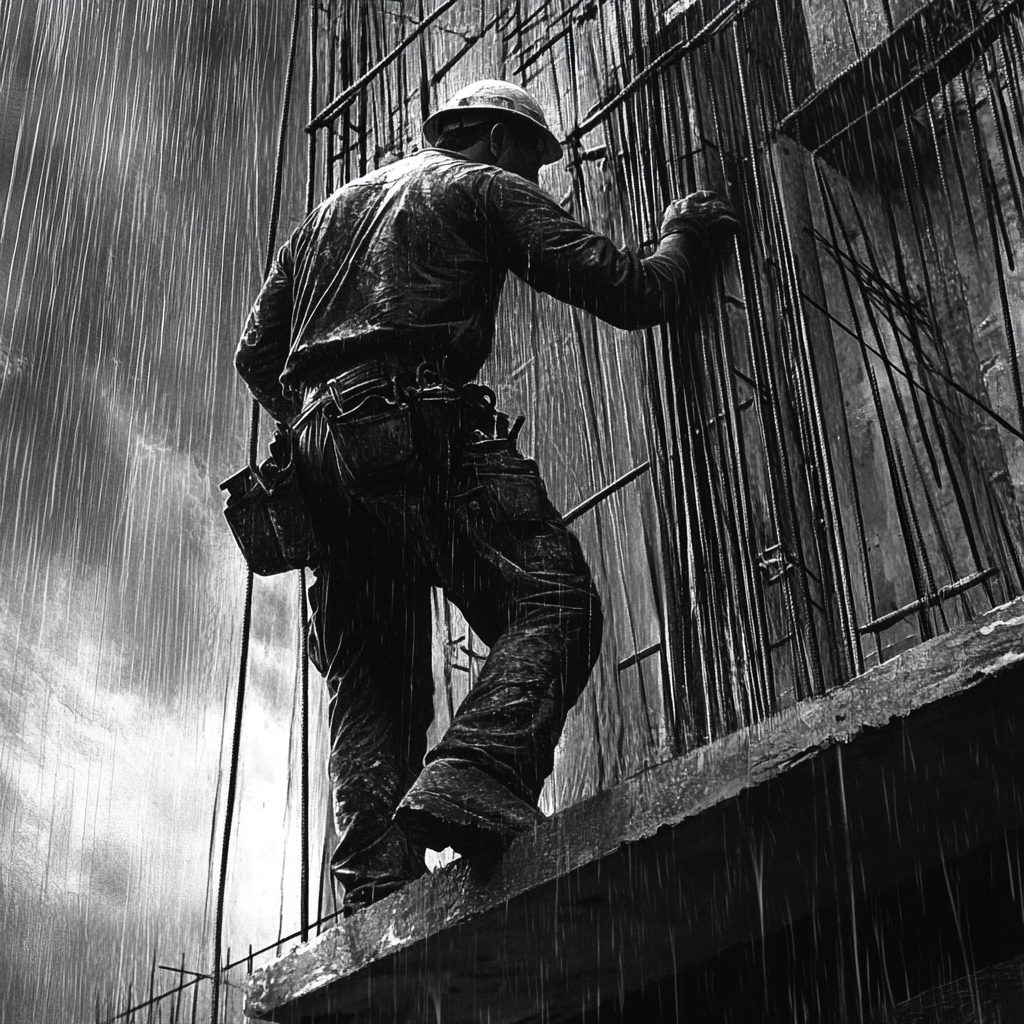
[282,150,506,385]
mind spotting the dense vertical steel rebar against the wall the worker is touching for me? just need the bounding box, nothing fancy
[282,0,1024,856]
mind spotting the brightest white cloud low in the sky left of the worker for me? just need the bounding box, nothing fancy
[0,544,311,1019]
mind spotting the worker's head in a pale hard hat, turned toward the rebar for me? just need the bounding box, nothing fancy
[423,79,562,182]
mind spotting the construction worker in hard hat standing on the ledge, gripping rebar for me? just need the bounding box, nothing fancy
[236,81,737,910]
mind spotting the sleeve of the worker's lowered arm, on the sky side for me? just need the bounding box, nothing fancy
[234,245,298,423]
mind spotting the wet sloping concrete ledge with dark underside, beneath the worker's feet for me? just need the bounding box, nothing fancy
[246,601,1024,1024]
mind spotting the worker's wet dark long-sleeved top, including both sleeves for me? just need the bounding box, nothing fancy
[236,150,694,421]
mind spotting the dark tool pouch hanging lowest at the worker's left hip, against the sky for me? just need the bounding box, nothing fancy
[220,430,322,575]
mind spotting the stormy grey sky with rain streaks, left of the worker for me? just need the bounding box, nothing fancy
[0,0,323,1024]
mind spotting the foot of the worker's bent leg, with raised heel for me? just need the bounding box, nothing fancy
[394,760,545,857]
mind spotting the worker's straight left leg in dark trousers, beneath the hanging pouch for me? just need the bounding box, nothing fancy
[303,418,433,908]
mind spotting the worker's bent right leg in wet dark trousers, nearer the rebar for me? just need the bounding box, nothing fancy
[396,444,602,852]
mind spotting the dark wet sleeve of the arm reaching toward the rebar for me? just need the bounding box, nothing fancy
[486,171,703,331]
